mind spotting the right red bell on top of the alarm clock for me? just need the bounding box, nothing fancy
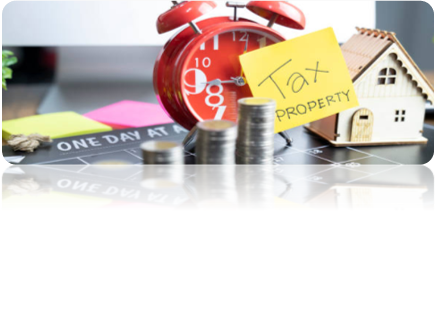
[247,0,306,30]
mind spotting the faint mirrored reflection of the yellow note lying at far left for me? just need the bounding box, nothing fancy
[2,190,112,211]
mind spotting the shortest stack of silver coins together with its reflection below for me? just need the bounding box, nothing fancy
[141,141,185,189]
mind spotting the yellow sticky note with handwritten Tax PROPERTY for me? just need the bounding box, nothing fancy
[240,28,359,133]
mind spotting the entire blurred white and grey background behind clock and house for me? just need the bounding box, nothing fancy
[2,0,434,120]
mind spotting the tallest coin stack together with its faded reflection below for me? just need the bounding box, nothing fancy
[236,98,276,210]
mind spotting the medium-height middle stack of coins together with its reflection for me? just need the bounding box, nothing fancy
[196,121,238,210]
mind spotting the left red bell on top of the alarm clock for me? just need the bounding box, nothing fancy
[157,1,217,34]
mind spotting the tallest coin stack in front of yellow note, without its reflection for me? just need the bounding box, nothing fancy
[236,98,276,164]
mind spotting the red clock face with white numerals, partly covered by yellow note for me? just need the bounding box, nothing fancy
[182,30,282,122]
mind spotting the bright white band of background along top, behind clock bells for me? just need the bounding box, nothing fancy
[2,0,376,46]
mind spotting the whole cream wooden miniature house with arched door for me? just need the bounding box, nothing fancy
[307,28,434,147]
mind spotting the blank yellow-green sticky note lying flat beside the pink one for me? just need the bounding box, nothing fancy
[2,112,112,140]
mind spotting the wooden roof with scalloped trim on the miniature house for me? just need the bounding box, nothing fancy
[341,28,434,102]
